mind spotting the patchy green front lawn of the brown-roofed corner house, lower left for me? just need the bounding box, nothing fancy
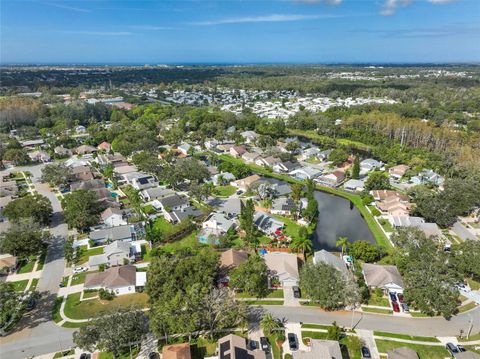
[65,293,148,319]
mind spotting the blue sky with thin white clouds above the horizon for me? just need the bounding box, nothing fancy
[0,0,480,64]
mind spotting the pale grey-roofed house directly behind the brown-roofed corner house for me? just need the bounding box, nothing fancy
[88,241,141,267]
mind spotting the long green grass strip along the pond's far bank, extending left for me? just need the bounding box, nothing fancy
[218,155,392,249]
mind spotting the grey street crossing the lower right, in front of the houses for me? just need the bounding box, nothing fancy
[263,305,480,336]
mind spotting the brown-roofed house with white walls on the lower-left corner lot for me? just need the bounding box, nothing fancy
[84,265,146,295]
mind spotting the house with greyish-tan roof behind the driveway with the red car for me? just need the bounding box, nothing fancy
[362,263,404,292]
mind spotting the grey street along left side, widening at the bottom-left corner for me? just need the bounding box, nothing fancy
[0,165,74,359]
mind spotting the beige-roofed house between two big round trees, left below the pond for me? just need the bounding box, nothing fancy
[263,252,300,287]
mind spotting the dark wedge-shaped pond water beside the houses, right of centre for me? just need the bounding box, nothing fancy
[313,191,376,251]
